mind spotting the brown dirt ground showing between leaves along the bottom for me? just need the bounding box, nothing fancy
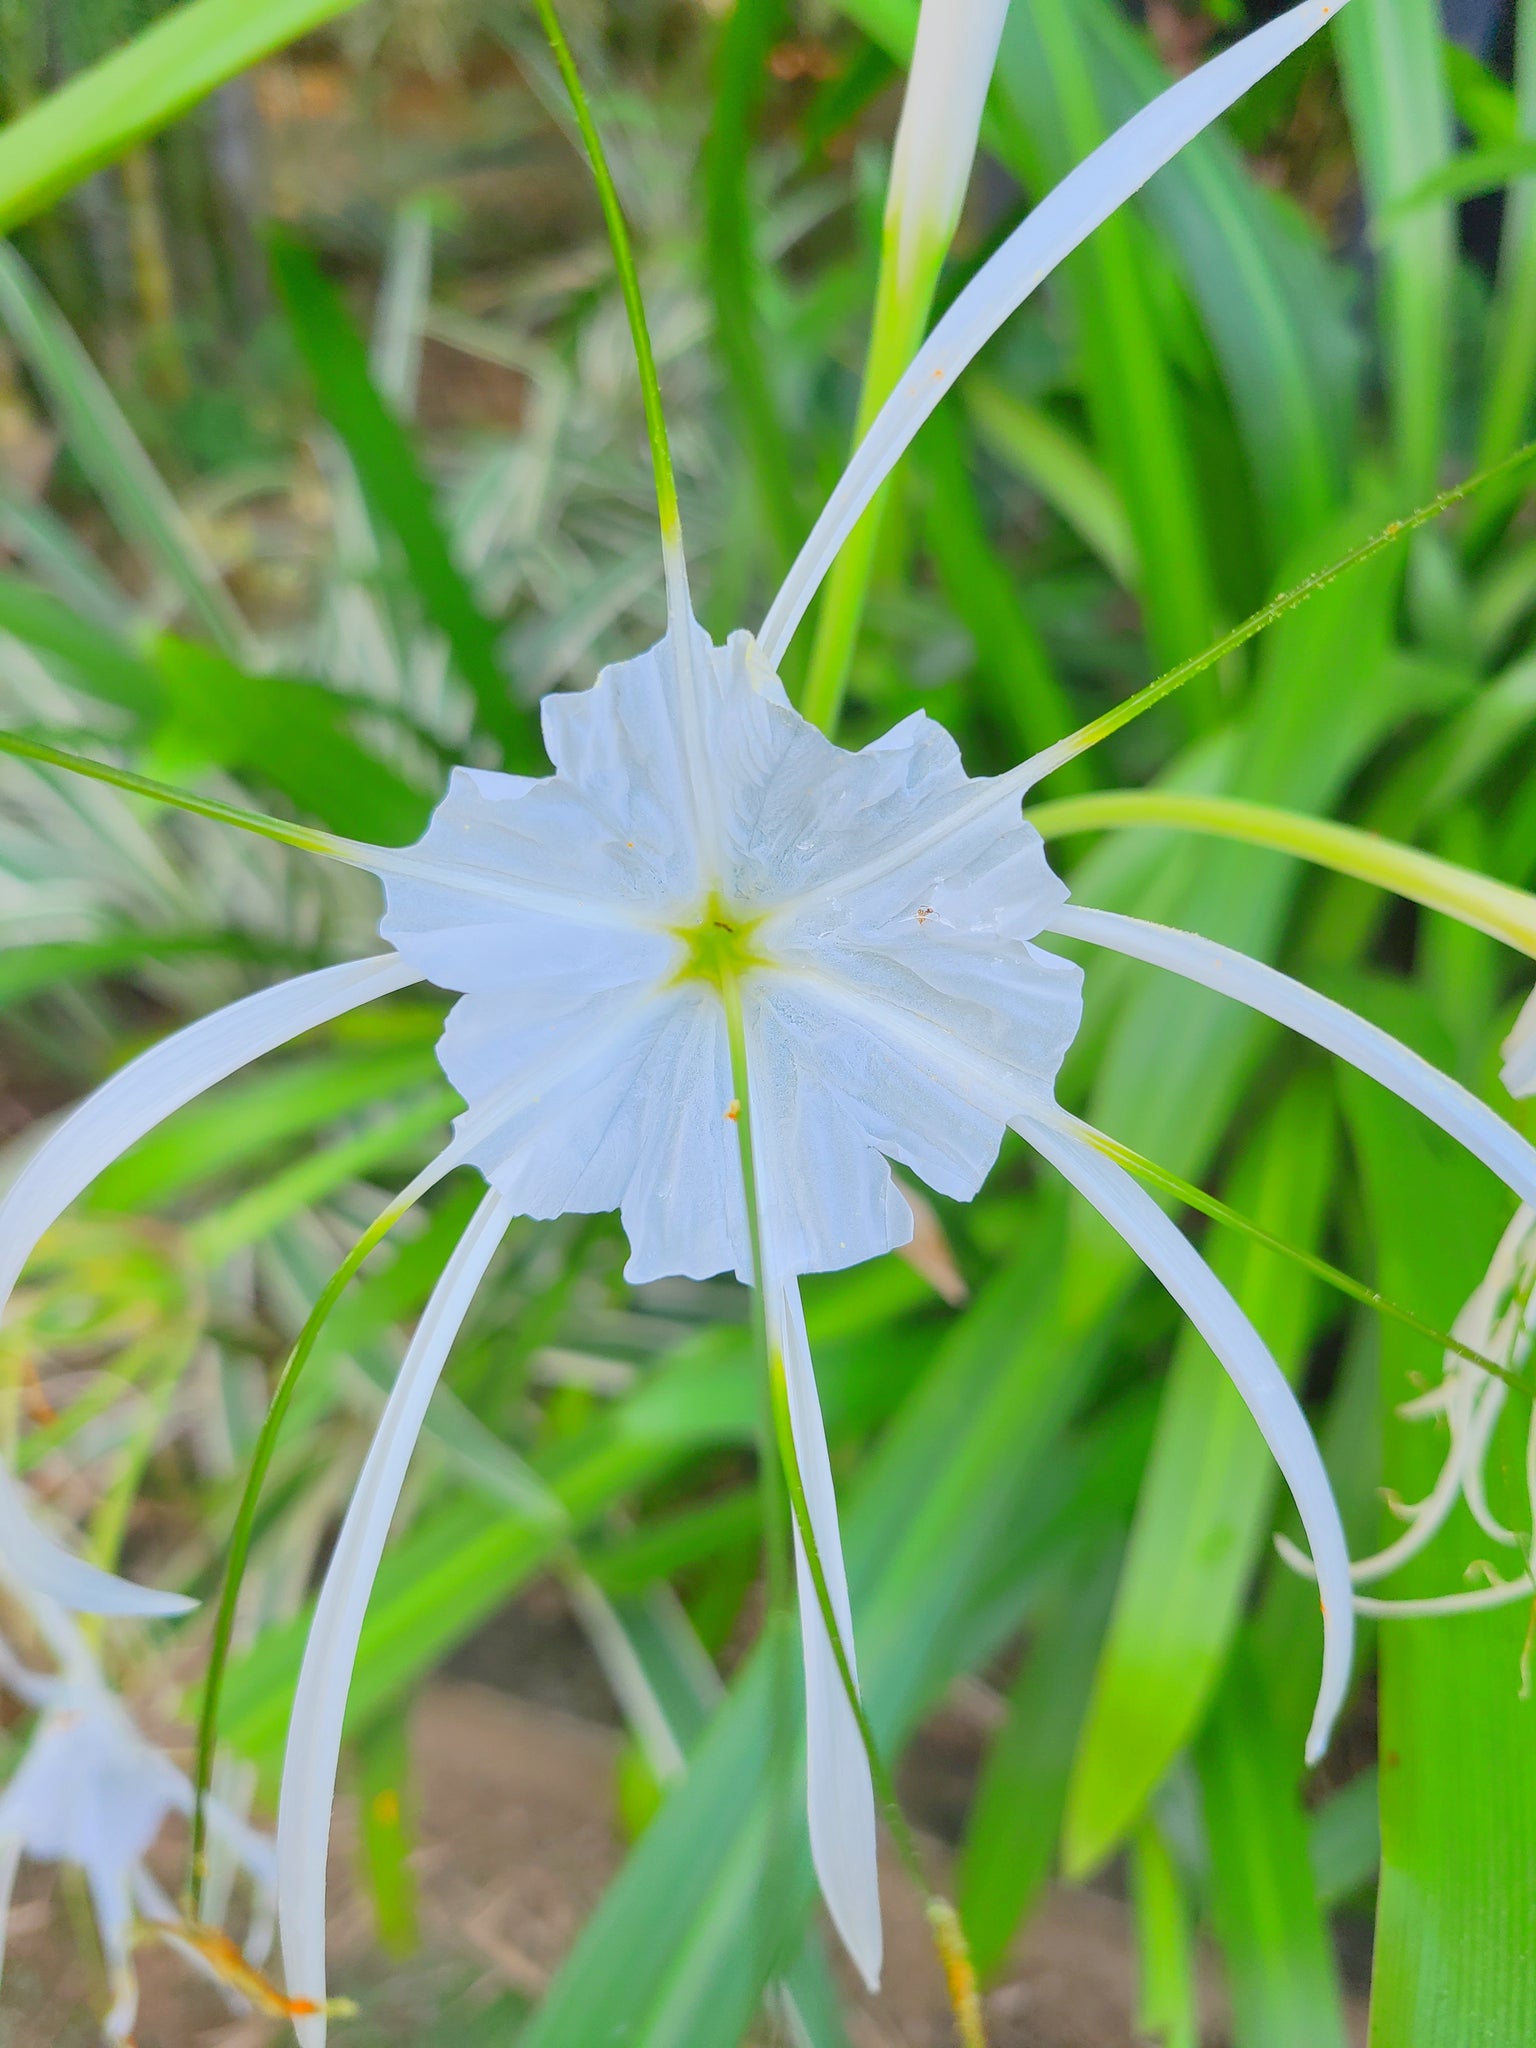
[0,1681,1179,2048]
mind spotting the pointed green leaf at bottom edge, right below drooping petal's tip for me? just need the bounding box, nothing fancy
[1198,1638,1343,2048]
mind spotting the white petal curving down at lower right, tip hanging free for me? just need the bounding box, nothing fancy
[1014,1110,1354,1763]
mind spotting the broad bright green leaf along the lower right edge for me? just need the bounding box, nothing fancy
[1339,983,1536,2048]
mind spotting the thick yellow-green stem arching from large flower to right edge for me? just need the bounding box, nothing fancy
[1024,788,1536,958]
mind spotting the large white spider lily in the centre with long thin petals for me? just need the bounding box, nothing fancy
[27,0,1536,2015]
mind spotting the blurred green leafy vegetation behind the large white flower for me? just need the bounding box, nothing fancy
[0,0,1536,2048]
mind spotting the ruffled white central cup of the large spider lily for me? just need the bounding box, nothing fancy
[381,627,1081,1280]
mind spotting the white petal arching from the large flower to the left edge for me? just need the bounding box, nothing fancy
[0,952,420,1305]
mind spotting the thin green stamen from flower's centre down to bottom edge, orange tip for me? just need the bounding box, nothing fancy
[719,973,987,2048]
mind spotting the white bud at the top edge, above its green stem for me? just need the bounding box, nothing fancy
[885,0,1008,293]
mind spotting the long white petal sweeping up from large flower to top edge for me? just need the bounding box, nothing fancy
[758,0,1346,670]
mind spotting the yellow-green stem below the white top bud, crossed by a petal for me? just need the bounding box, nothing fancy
[801,227,944,733]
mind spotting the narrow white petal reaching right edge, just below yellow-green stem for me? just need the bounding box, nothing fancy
[1051,903,1536,1206]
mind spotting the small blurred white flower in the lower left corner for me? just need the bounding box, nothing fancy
[0,1581,276,2044]
